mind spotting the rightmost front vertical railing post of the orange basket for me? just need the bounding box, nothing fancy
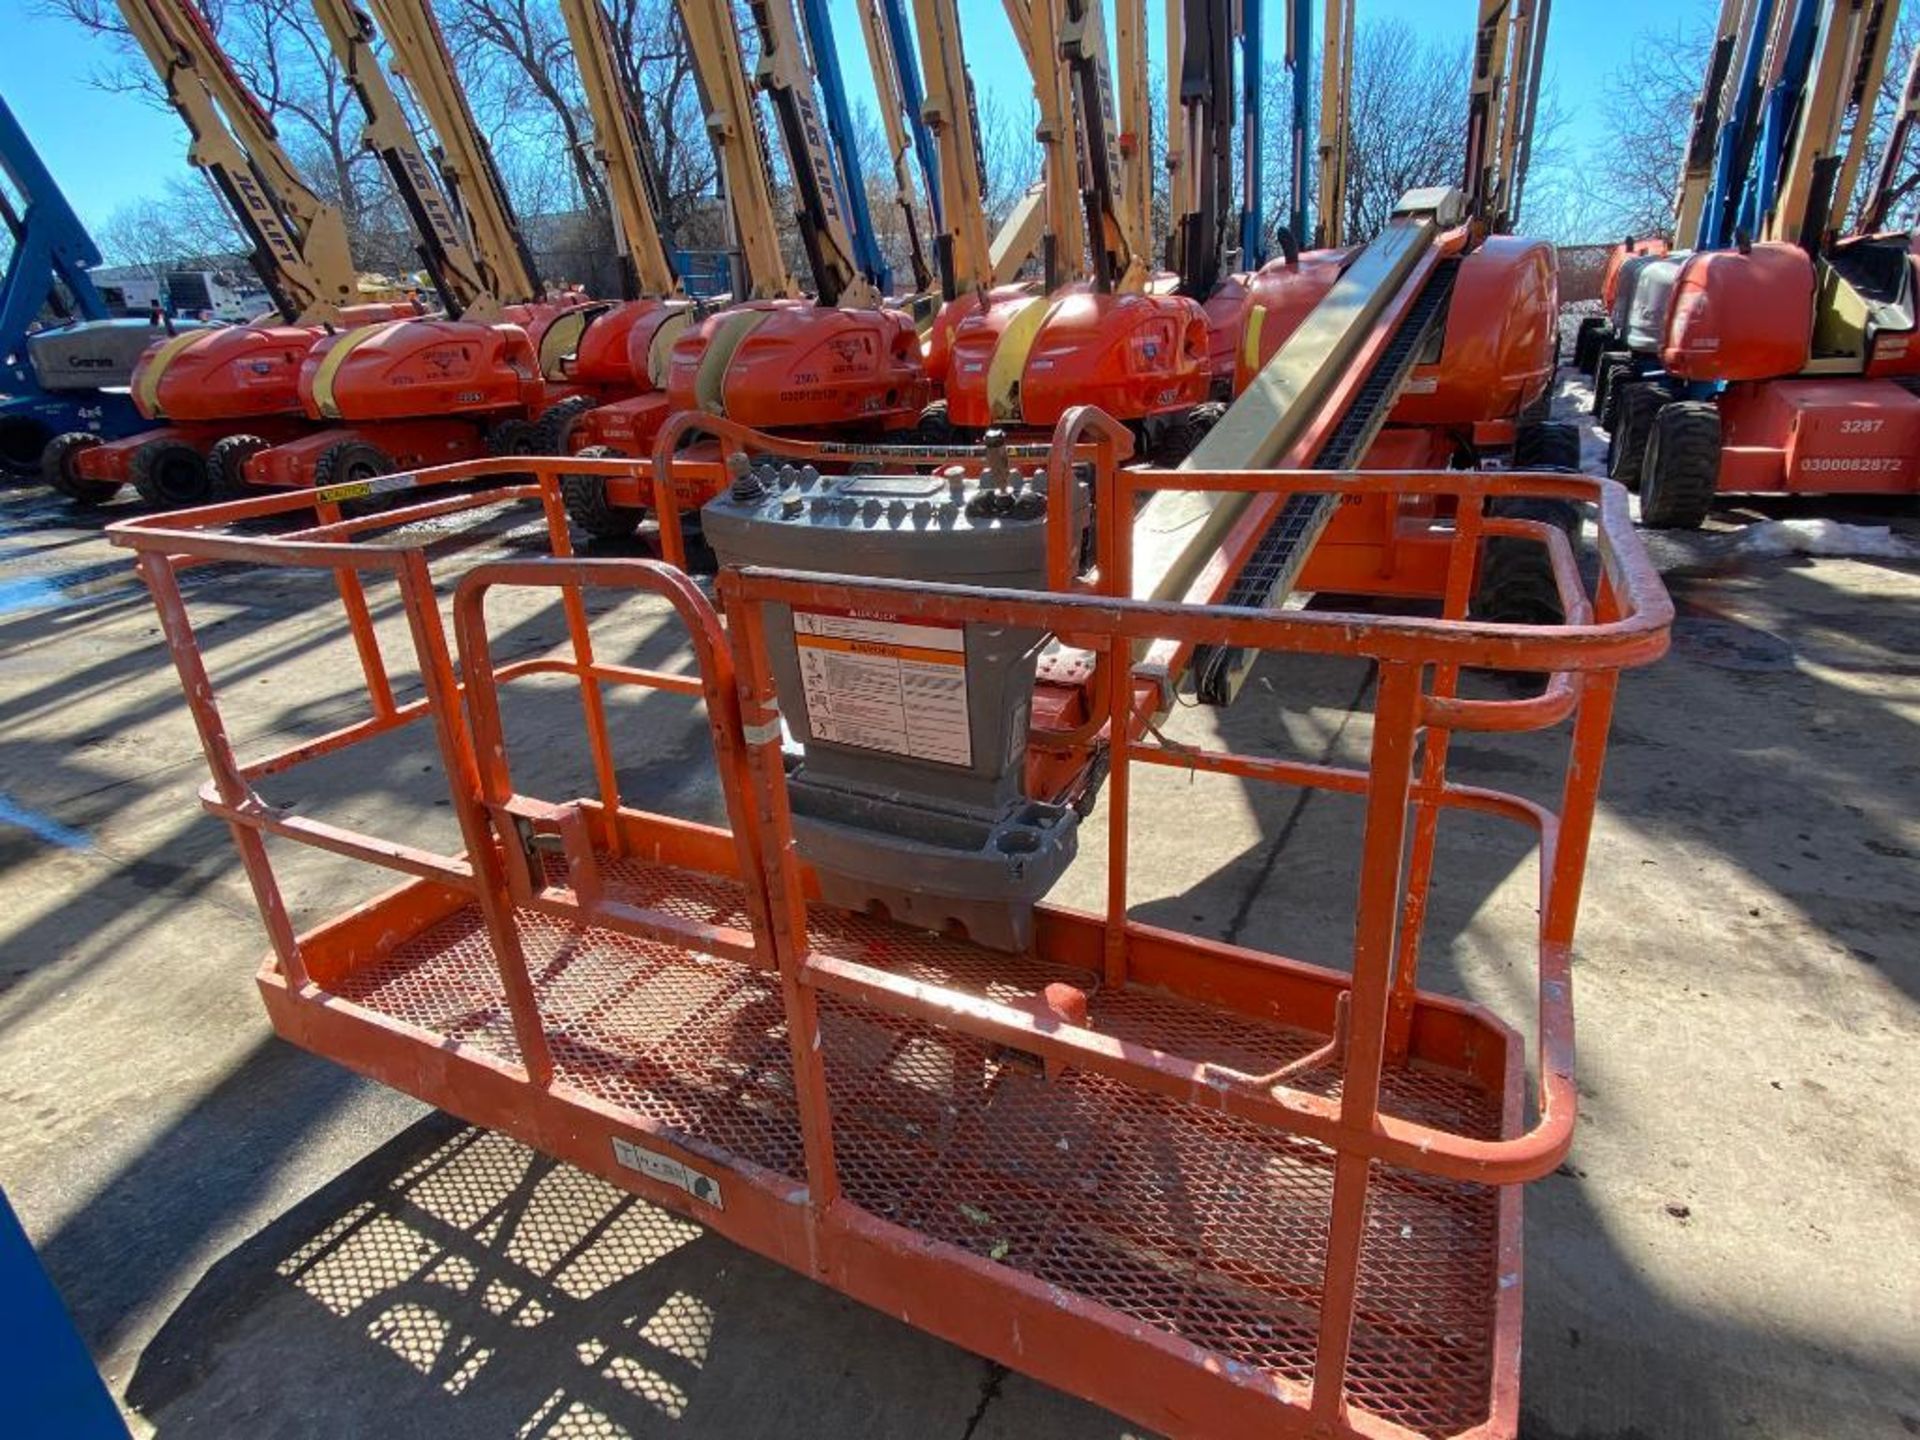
[1311,660,1423,1425]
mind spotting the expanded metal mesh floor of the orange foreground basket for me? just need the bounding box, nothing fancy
[326,860,1500,1434]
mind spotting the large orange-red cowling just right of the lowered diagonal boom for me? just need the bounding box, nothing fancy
[1388,234,1559,424]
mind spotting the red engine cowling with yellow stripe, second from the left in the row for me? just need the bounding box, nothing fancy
[300,315,551,420]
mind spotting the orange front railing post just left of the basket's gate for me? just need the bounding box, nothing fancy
[394,551,553,1089]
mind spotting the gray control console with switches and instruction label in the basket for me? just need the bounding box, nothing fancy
[701,449,1087,950]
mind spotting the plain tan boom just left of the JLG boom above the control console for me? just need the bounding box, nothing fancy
[680,0,801,300]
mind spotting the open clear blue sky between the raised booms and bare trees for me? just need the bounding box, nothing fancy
[0,0,1715,234]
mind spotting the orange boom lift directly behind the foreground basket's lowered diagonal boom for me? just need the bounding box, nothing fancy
[1235,0,1580,622]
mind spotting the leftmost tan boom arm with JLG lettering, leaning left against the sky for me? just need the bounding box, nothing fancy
[119,0,359,321]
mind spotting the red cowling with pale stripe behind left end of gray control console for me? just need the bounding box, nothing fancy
[666,300,931,430]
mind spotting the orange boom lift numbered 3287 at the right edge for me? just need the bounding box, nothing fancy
[1601,0,1920,528]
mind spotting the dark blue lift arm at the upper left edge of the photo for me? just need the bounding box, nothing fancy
[0,100,108,347]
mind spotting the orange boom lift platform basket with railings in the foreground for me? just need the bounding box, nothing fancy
[113,422,1672,1436]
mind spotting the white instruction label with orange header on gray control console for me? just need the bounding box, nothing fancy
[793,611,973,764]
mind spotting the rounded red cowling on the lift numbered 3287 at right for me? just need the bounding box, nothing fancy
[1661,240,1814,382]
